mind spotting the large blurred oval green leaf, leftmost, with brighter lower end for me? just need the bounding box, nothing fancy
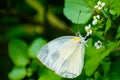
[8,39,29,66]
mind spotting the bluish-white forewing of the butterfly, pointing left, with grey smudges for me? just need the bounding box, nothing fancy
[37,36,74,68]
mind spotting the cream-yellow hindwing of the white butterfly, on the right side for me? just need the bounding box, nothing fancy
[52,39,84,78]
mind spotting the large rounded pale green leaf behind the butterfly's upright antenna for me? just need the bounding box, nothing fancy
[64,0,92,24]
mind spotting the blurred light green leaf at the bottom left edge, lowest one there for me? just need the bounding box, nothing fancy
[8,67,26,80]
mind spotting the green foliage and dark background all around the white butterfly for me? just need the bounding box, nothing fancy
[0,0,120,80]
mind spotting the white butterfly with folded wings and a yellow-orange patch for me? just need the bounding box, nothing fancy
[37,35,86,78]
